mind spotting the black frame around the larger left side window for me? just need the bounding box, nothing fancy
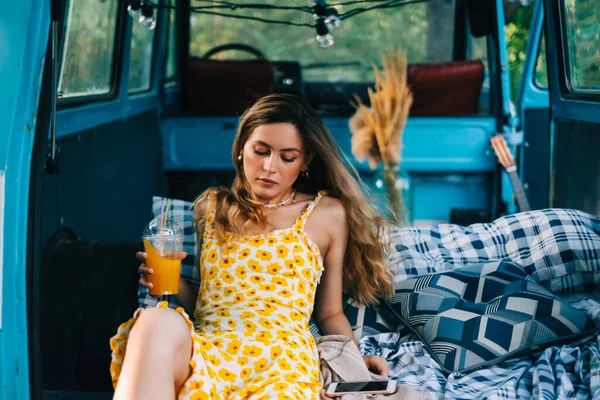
[56,0,127,109]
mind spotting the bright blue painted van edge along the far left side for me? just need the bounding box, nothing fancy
[0,0,50,399]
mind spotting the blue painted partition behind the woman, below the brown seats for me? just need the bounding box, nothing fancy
[161,117,495,172]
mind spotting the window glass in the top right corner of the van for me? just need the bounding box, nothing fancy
[563,0,600,91]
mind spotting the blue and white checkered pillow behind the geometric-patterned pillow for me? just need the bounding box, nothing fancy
[389,209,600,293]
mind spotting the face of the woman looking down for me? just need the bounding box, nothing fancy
[242,122,307,202]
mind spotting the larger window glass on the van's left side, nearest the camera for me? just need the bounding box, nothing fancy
[58,0,119,98]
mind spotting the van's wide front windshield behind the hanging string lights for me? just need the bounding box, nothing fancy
[189,0,455,82]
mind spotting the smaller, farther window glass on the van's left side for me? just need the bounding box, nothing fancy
[127,21,156,93]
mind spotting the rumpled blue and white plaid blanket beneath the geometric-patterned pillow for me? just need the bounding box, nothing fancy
[360,293,600,400]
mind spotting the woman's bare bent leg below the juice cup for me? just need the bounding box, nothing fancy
[114,308,192,400]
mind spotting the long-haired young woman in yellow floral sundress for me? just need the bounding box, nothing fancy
[111,95,393,399]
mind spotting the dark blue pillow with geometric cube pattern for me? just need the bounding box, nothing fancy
[386,261,598,373]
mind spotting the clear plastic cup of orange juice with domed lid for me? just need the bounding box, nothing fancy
[142,218,183,297]
